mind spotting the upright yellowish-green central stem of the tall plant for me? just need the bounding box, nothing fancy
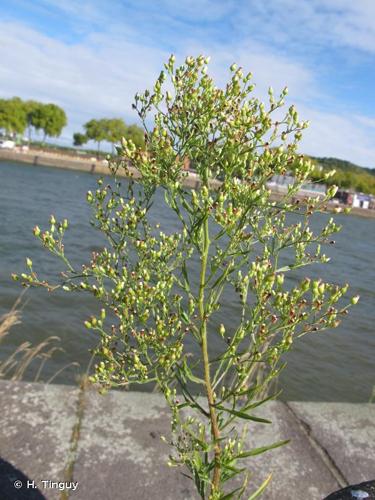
[199,216,221,492]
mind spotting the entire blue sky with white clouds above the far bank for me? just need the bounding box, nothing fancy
[0,0,375,168]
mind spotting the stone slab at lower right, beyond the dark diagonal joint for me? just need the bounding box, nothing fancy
[290,402,375,484]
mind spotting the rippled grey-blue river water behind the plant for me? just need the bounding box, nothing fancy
[0,162,375,402]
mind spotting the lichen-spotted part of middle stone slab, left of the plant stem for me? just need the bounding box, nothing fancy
[71,391,196,500]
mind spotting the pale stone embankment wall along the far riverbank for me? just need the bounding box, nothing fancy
[0,149,375,218]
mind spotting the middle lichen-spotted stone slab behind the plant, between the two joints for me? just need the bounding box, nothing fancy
[71,392,339,500]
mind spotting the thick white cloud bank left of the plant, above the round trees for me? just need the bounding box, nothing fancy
[0,19,168,141]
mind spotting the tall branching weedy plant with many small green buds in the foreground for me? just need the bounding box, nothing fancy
[16,56,358,500]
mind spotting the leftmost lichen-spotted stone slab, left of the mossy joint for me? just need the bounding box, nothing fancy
[0,381,78,500]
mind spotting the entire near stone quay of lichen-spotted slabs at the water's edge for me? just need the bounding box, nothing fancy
[0,381,375,500]
